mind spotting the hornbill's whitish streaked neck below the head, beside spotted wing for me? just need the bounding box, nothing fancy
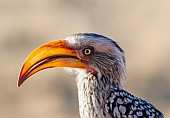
[77,74,111,118]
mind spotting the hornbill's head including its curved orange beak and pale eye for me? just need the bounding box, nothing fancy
[18,33,126,87]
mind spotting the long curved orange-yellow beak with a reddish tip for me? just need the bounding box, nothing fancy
[18,40,86,87]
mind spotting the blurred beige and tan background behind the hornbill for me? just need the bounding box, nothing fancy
[0,0,170,118]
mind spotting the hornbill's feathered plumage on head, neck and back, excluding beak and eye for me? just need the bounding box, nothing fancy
[66,33,163,118]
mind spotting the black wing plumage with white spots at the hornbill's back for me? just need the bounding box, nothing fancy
[105,87,163,118]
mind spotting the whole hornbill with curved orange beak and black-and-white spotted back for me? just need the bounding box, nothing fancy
[18,33,163,118]
